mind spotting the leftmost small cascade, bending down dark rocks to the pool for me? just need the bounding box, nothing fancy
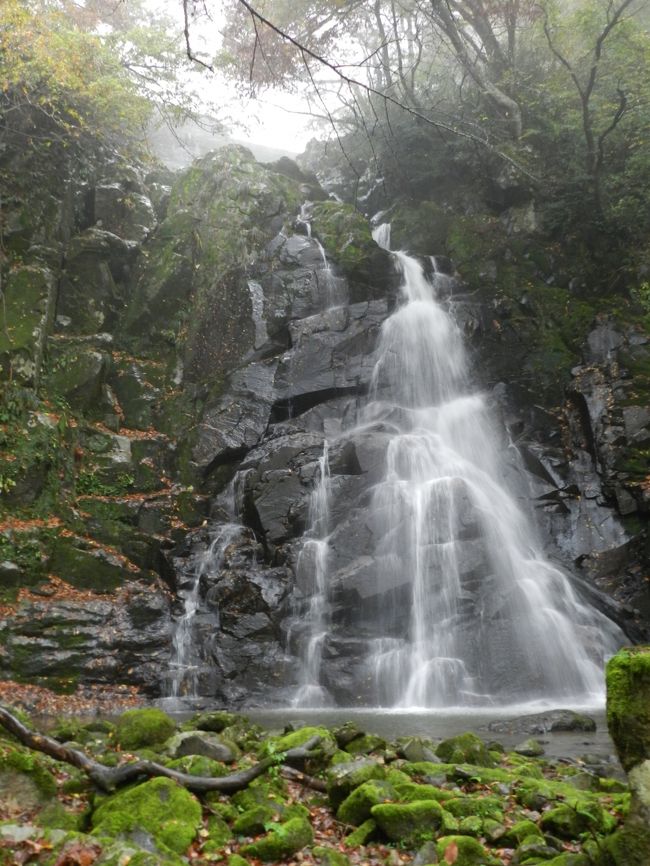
[169,523,242,698]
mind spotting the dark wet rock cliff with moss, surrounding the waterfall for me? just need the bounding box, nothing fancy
[0,137,650,702]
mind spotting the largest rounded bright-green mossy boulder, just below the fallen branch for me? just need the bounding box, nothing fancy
[91,778,202,854]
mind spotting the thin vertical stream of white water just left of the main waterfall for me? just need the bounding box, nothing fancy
[293,440,332,707]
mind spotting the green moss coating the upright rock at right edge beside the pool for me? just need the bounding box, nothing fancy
[606,646,650,771]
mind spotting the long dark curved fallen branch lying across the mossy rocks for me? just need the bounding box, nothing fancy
[0,705,320,794]
